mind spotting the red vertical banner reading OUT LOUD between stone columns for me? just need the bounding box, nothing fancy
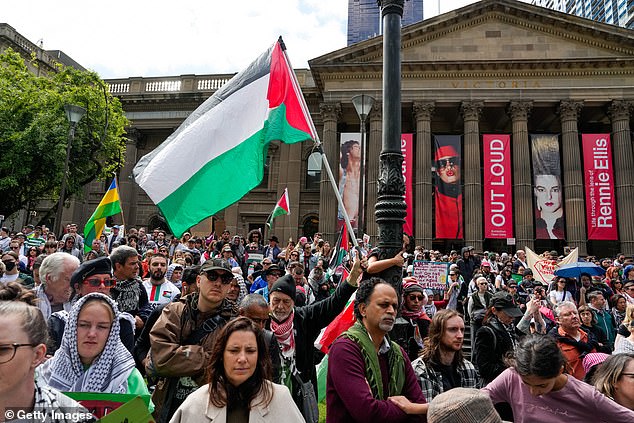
[482,134,513,238]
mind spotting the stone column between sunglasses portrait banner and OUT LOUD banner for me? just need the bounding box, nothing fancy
[461,101,484,251]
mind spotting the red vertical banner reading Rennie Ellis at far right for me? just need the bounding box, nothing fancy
[581,134,618,241]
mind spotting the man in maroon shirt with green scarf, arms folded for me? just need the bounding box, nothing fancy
[326,277,425,422]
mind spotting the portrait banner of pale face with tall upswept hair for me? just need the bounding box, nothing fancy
[531,134,566,239]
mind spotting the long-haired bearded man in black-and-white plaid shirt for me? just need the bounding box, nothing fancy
[412,309,481,401]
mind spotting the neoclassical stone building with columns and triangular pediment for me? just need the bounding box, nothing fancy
[49,0,634,255]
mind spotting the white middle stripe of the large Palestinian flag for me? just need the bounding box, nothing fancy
[137,74,270,203]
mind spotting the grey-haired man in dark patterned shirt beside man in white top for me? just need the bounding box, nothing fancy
[110,245,152,330]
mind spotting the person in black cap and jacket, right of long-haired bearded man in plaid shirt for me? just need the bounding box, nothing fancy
[473,291,546,388]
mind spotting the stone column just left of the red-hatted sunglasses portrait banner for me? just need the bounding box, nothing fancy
[414,101,436,249]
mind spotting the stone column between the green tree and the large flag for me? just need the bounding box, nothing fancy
[120,128,140,230]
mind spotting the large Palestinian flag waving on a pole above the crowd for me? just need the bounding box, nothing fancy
[133,38,317,237]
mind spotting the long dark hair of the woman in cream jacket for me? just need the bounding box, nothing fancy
[207,317,273,408]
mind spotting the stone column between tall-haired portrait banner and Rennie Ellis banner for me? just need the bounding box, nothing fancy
[559,100,588,256]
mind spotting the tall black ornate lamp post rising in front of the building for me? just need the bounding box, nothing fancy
[375,0,406,298]
